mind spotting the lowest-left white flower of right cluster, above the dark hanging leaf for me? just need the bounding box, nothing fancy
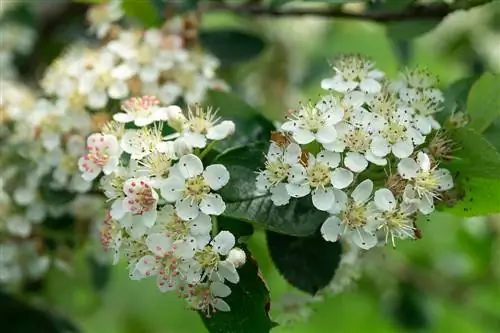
[321,179,377,246]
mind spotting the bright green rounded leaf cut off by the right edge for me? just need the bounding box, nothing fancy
[467,73,500,133]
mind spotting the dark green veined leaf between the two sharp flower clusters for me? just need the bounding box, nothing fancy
[214,143,328,236]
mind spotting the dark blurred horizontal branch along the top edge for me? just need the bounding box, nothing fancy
[204,0,488,22]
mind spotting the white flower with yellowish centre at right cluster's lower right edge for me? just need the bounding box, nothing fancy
[398,152,453,214]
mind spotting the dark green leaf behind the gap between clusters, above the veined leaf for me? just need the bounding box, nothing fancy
[207,91,275,152]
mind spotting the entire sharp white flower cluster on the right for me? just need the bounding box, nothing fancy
[256,55,453,249]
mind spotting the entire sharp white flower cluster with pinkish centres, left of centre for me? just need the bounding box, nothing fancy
[78,96,246,316]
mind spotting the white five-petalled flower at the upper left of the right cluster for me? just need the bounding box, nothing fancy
[281,102,344,145]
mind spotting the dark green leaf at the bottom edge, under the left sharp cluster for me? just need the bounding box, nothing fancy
[200,252,276,333]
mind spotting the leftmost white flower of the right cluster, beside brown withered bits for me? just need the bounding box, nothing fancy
[256,142,302,206]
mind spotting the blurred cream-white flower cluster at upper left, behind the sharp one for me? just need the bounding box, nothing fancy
[42,1,225,110]
